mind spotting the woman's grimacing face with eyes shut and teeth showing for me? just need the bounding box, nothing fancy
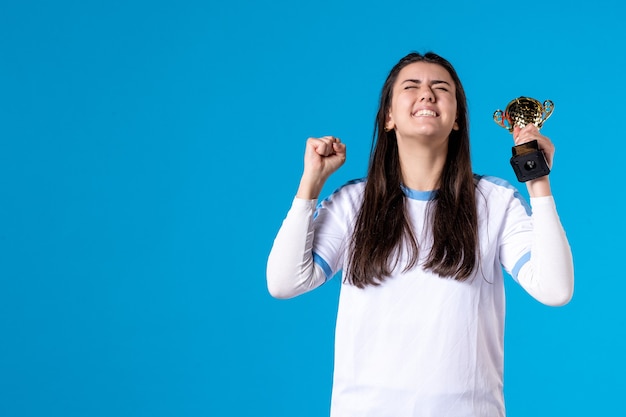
[385,62,459,140]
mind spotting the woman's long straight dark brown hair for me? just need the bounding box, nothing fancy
[346,52,478,288]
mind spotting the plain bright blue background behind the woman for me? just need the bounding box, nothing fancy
[0,0,626,417]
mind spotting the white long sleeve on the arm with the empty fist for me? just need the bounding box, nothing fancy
[267,198,326,298]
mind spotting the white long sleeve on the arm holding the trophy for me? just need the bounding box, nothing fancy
[518,196,574,306]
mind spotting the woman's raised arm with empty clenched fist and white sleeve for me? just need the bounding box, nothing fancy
[267,136,346,298]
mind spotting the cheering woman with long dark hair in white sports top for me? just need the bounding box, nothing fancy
[267,53,573,417]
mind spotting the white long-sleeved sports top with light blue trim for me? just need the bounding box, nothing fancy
[268,177,573,417]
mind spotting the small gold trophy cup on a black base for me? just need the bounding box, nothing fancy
[493,97,554,182]
